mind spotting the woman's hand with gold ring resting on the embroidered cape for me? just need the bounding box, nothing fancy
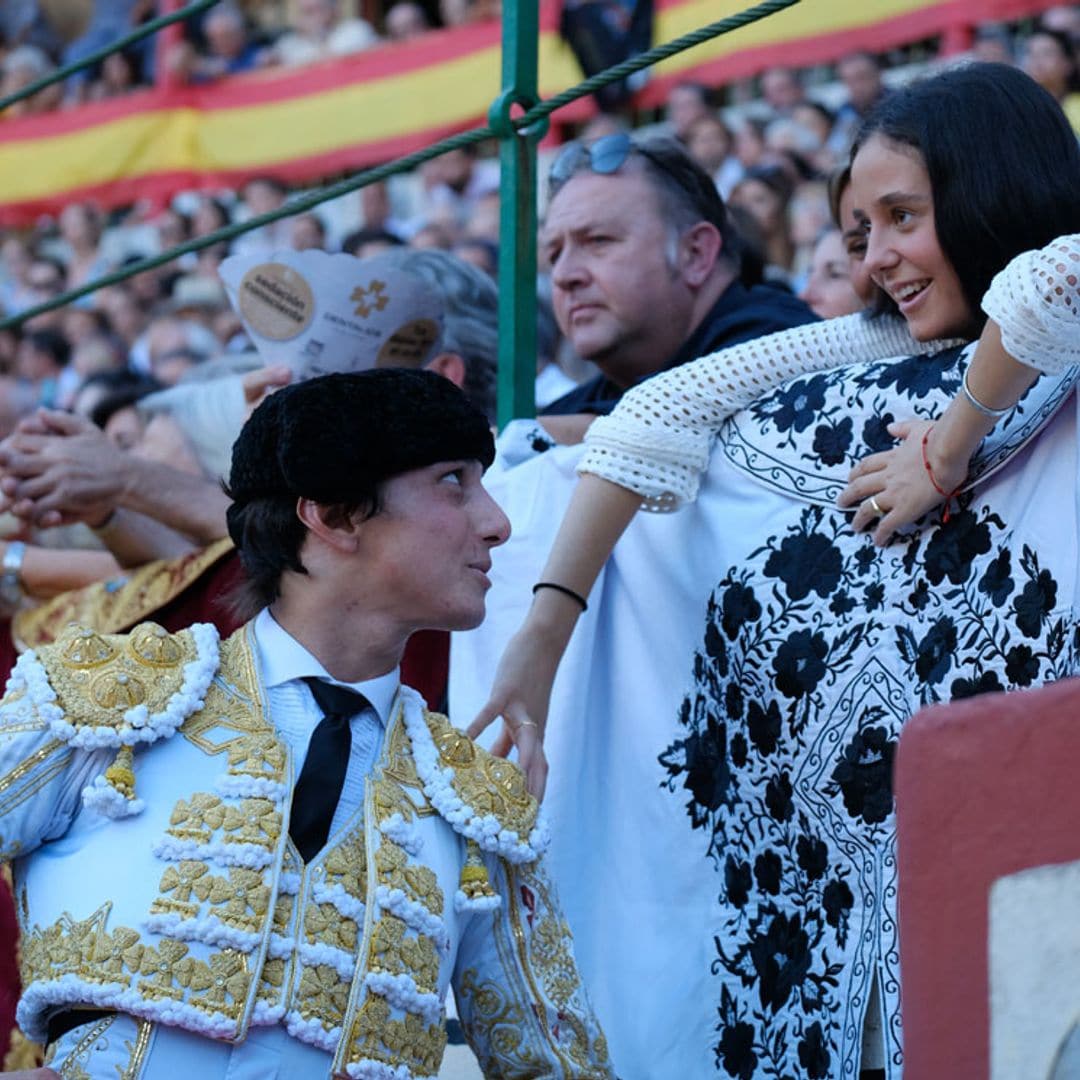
[836,420,968,548]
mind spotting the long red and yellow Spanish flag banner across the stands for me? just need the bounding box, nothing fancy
[0,0,1052,225]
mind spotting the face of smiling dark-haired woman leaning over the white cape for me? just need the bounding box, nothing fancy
[851,135,977,341]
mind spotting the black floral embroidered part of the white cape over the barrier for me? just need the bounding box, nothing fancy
[659,351,1077,1080]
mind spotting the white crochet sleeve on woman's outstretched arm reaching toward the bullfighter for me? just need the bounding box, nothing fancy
[578,314,942,512]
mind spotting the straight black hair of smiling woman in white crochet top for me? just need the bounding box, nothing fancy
[851,64,1080,326]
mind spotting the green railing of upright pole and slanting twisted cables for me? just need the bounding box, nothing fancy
[0,0,799,427]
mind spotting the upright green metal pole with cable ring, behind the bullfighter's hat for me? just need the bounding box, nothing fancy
[488,0,548,428]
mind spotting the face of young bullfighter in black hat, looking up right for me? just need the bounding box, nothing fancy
[357,461,510,630]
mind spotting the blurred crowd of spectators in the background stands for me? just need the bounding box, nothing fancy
[0,0,1080,494]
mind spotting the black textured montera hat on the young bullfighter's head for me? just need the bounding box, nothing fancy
[228,368,495,516]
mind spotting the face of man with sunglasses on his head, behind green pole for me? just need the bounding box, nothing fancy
[540,173,693,387]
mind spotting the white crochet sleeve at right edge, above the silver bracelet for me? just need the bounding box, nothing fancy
[983,233,1080,375]
